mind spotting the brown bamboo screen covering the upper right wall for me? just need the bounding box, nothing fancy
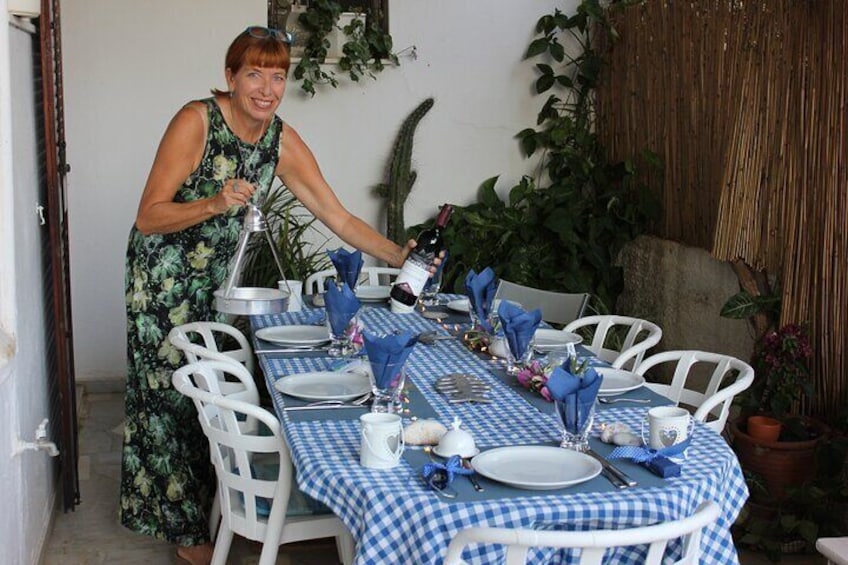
[598,0,848,416]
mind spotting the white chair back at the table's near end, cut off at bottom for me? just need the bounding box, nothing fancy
[444,500,720,565]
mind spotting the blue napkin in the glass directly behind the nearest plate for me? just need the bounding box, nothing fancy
[547,362,604,434]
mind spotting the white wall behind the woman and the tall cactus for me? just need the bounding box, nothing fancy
[61,0,564,381]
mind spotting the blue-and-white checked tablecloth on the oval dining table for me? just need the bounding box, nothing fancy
[250,295,748,564]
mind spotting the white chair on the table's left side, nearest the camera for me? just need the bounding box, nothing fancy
[172,361,354,565]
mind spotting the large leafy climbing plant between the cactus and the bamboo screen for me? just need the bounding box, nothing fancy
[410,0,659,310]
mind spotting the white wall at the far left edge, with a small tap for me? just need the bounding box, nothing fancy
[0,12,58,564]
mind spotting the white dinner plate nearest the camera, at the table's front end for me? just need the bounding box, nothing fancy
[471,445,601,490]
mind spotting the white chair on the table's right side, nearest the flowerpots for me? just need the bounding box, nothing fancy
[634,350,754,434]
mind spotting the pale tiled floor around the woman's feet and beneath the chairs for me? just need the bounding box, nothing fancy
[43,393,824,565]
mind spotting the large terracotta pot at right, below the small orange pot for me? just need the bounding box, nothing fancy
[730,419,830,499]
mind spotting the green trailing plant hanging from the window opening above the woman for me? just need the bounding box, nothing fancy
[294,0,399,96]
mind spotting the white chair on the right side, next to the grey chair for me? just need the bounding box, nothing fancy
[564,315,662,369]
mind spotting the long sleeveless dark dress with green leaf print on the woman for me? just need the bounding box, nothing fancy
[119,98,283,546]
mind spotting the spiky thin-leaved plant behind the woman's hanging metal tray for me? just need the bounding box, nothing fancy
[242,184,330,288]
